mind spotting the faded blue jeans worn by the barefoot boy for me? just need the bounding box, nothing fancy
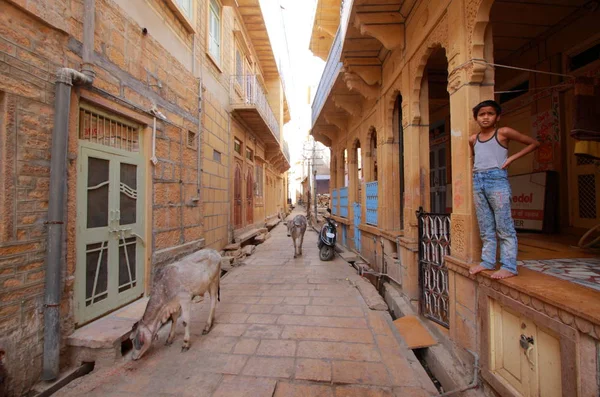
[473,168,517,274]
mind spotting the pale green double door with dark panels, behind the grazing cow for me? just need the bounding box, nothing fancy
[75,140,145,325]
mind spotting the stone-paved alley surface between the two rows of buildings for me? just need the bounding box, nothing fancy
[57,209,436,397]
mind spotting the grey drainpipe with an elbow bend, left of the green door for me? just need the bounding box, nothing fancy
[41,0,95,381]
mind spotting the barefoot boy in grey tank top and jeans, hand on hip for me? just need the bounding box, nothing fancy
[469,101,540,279]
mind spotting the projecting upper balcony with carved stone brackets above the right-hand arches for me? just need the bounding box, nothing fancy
[311,0,408,146]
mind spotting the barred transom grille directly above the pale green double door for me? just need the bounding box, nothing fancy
[79,106,140,153]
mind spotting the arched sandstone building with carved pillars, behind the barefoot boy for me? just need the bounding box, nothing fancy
[311,0,600,396]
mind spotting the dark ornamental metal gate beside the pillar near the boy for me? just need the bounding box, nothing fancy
[417,207,450,328]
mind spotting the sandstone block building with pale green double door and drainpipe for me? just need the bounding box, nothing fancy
[0,0,290,395]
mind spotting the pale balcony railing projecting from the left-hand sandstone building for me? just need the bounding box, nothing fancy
[230,74,281,142]
